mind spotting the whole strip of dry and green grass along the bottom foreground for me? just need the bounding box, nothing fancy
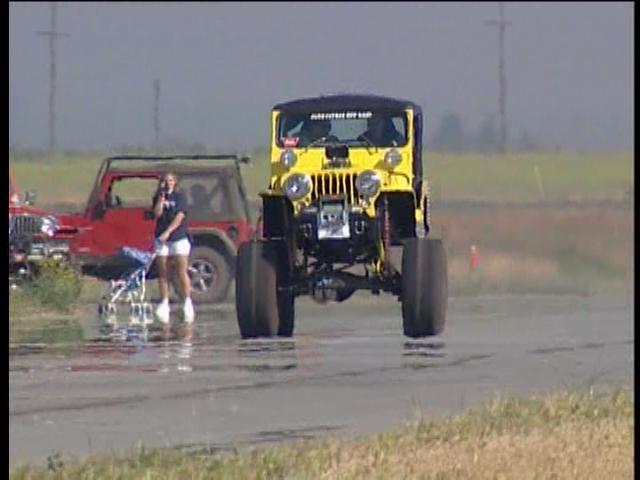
[10,390,634,480]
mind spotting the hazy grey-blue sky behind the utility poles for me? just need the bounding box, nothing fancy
[9,2,634,150]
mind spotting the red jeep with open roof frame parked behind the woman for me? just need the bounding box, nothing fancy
[56,155,254,303]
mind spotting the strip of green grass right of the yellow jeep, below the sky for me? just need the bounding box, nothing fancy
[424,152,633,202]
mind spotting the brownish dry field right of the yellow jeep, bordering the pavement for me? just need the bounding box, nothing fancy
[433,204,633,294]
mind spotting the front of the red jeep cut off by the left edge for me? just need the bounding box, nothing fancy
[9,166,69,285]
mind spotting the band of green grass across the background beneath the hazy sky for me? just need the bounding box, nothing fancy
[9,151,633,208]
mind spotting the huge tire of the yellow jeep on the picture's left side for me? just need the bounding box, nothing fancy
[236,240,295,338]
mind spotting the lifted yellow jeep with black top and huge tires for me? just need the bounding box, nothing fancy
[236,95,447,338]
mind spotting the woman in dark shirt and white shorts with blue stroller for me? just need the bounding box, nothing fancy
[153,173,195,324]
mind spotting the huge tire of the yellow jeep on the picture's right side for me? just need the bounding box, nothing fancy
[402,238,448,338]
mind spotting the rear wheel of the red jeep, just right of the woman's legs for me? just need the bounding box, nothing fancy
[189,246,231,303]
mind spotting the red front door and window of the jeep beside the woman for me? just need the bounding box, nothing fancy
[91,177,158,257]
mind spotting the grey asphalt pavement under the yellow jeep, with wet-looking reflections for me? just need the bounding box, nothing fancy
[9,296,634,466]
